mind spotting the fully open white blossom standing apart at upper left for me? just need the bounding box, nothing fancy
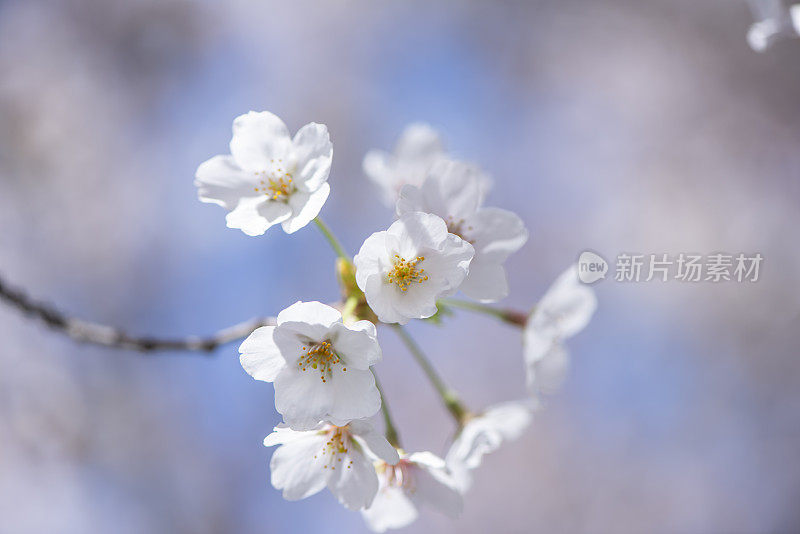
[195,111,333,236]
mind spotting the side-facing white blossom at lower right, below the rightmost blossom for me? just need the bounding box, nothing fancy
[445,399,536,493]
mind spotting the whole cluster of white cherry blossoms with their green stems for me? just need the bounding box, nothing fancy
[195,112,596,532]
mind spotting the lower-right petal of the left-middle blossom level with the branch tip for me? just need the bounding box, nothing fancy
[324,366,381,426]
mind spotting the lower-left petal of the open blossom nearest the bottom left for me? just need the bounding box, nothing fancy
[270,433,327,501]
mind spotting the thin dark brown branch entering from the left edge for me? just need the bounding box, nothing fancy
[0,277,275,353]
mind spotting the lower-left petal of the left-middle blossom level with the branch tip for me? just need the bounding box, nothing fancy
[274,365,334,430]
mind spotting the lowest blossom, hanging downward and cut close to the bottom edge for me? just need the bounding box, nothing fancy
[361,452,463,532]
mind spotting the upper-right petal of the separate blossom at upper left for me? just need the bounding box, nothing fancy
[292,122,333,191]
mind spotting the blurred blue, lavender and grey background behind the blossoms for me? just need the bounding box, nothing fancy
[0,0,800,534]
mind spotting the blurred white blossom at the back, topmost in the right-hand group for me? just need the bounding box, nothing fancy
[363,123,445,208]
